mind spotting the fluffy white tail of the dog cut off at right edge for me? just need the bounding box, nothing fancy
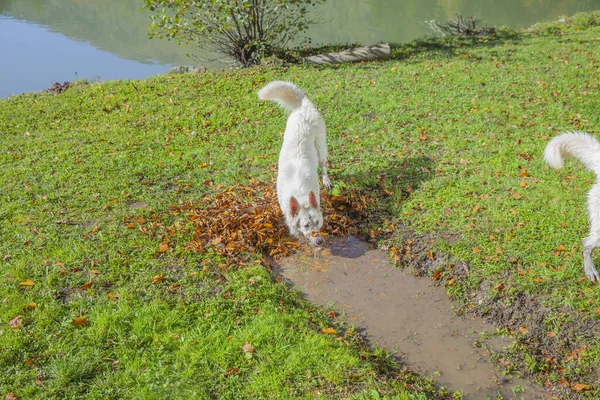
[544,132,600,176]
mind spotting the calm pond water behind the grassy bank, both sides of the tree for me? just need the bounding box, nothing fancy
[0,0,600,98]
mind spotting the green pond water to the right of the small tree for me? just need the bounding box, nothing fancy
[311,0,600,44]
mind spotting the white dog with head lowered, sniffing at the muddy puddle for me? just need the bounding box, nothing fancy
[258,81,331,245]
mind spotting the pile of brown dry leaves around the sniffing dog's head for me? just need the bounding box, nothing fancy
[152,179,375,262]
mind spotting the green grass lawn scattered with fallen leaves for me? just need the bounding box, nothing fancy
[0,9,600,399]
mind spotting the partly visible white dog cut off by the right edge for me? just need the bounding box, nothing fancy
[544,132,600,282]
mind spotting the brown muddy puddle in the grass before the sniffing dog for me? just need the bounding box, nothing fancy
[276,237,547,399]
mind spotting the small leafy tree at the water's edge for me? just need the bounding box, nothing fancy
[144,0,325,66]
